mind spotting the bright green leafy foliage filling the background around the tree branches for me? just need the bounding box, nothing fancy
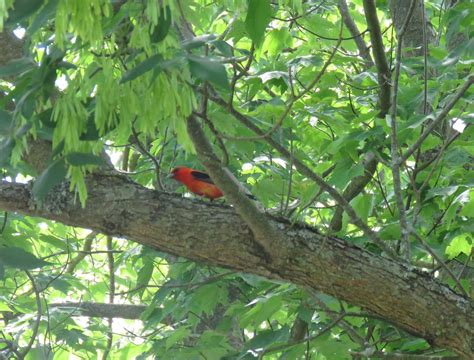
[0,0,474,359]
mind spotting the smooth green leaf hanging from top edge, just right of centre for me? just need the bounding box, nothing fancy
[245,0,272,46]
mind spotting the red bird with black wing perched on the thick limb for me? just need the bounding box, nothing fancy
[170,166,224,200]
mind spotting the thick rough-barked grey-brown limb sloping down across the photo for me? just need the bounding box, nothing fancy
[0,175,474,358]
